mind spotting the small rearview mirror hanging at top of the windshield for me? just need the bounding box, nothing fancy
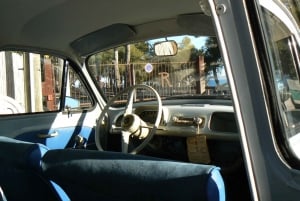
[154,41,178,56]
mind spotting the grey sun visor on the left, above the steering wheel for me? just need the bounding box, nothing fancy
[71,24,136,56]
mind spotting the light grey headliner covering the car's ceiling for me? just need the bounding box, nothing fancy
[0,0,213,57]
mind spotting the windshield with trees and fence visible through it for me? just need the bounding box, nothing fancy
[88,35,230,101]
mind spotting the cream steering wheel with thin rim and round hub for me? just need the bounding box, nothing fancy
[95,85,162,154]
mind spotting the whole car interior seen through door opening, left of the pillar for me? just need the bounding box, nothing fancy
[0,0,251,201]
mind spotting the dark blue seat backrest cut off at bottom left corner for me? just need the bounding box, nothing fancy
[0,136,69,201]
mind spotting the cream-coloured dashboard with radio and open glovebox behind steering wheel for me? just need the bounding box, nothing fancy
[111,99,239,140]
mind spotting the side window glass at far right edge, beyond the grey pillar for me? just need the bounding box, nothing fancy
[262,1,300,159]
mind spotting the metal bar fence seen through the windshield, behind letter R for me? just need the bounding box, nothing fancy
[90,62,201,99]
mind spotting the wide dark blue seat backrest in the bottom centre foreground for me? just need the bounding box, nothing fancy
[42,149,225,201]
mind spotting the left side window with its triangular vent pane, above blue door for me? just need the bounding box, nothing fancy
[0,51,92,115]
